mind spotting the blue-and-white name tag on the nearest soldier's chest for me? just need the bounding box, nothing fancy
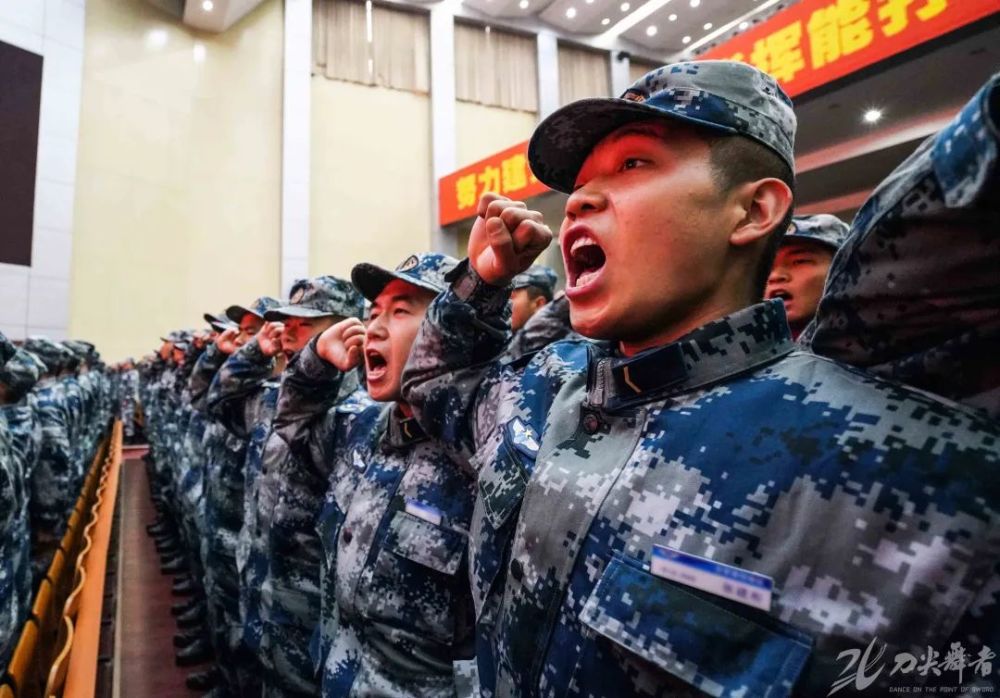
[650,545,774,611]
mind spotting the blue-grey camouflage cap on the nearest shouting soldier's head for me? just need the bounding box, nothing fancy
[528,61,796,194]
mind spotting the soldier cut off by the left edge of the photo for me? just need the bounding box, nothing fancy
[0,342,45,648]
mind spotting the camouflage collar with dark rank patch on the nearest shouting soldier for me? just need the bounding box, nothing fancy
[587,300,795,410]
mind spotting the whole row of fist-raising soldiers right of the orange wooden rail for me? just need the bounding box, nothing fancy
[1,61,1000,698]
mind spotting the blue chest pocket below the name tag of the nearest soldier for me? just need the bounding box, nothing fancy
[574,558,812,698]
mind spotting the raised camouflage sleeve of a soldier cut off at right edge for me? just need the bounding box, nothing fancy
[802,75,1000,419]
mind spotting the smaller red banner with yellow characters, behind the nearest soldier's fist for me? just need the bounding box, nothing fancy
[438,141,549,225]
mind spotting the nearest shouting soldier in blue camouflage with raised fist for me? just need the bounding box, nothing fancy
[403,61,1000,696]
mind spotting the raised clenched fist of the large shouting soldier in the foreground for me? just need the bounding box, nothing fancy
[469,192,552,286]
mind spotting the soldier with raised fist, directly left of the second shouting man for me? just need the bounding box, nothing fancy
[208,276,356,696]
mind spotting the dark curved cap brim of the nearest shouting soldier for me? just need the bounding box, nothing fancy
[528,97,736,194]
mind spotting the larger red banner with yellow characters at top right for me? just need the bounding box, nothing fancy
[700,0,1000,97]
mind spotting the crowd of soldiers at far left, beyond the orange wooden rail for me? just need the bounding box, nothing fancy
[0,334,126,667]
